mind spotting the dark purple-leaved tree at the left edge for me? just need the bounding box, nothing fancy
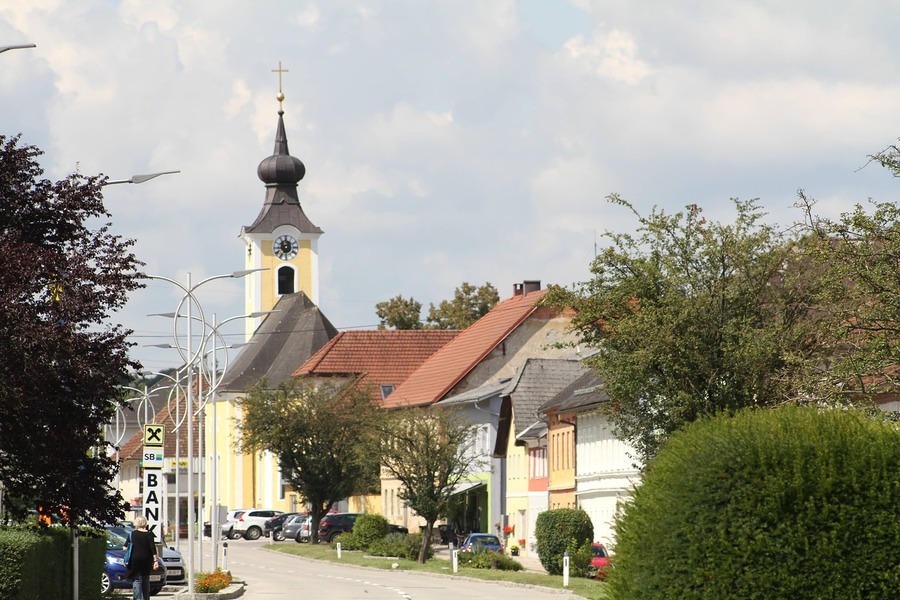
[0,136,141,524]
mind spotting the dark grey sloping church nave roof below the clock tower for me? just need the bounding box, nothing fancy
[219,292,338,392]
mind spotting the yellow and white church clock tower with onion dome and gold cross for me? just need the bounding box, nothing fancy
[241,78,323,340]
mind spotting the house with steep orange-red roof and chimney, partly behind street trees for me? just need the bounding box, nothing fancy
[382,281,575,531]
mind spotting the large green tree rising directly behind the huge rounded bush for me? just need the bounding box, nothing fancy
[545,196,829,461]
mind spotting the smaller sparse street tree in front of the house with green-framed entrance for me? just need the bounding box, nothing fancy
[381,406,480,564]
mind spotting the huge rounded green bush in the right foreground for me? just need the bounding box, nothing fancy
[609,406,900,600]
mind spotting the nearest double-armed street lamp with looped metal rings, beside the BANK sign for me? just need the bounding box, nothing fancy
[145,269,265,594]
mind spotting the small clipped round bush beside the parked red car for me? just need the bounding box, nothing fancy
[534,508,594,575]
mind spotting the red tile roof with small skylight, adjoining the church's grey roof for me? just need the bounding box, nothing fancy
[294,329,462,402]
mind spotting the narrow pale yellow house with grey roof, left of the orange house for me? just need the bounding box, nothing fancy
[496,355,588,554]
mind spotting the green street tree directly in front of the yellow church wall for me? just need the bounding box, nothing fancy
[238,380,382,543]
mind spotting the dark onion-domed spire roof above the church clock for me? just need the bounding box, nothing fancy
[242,110,322,236]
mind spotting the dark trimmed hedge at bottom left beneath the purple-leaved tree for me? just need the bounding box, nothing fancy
[0,527,106,600]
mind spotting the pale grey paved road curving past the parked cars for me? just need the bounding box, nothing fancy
[156,540,571,600]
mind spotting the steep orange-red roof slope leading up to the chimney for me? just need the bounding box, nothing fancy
[384,289,547,408]
